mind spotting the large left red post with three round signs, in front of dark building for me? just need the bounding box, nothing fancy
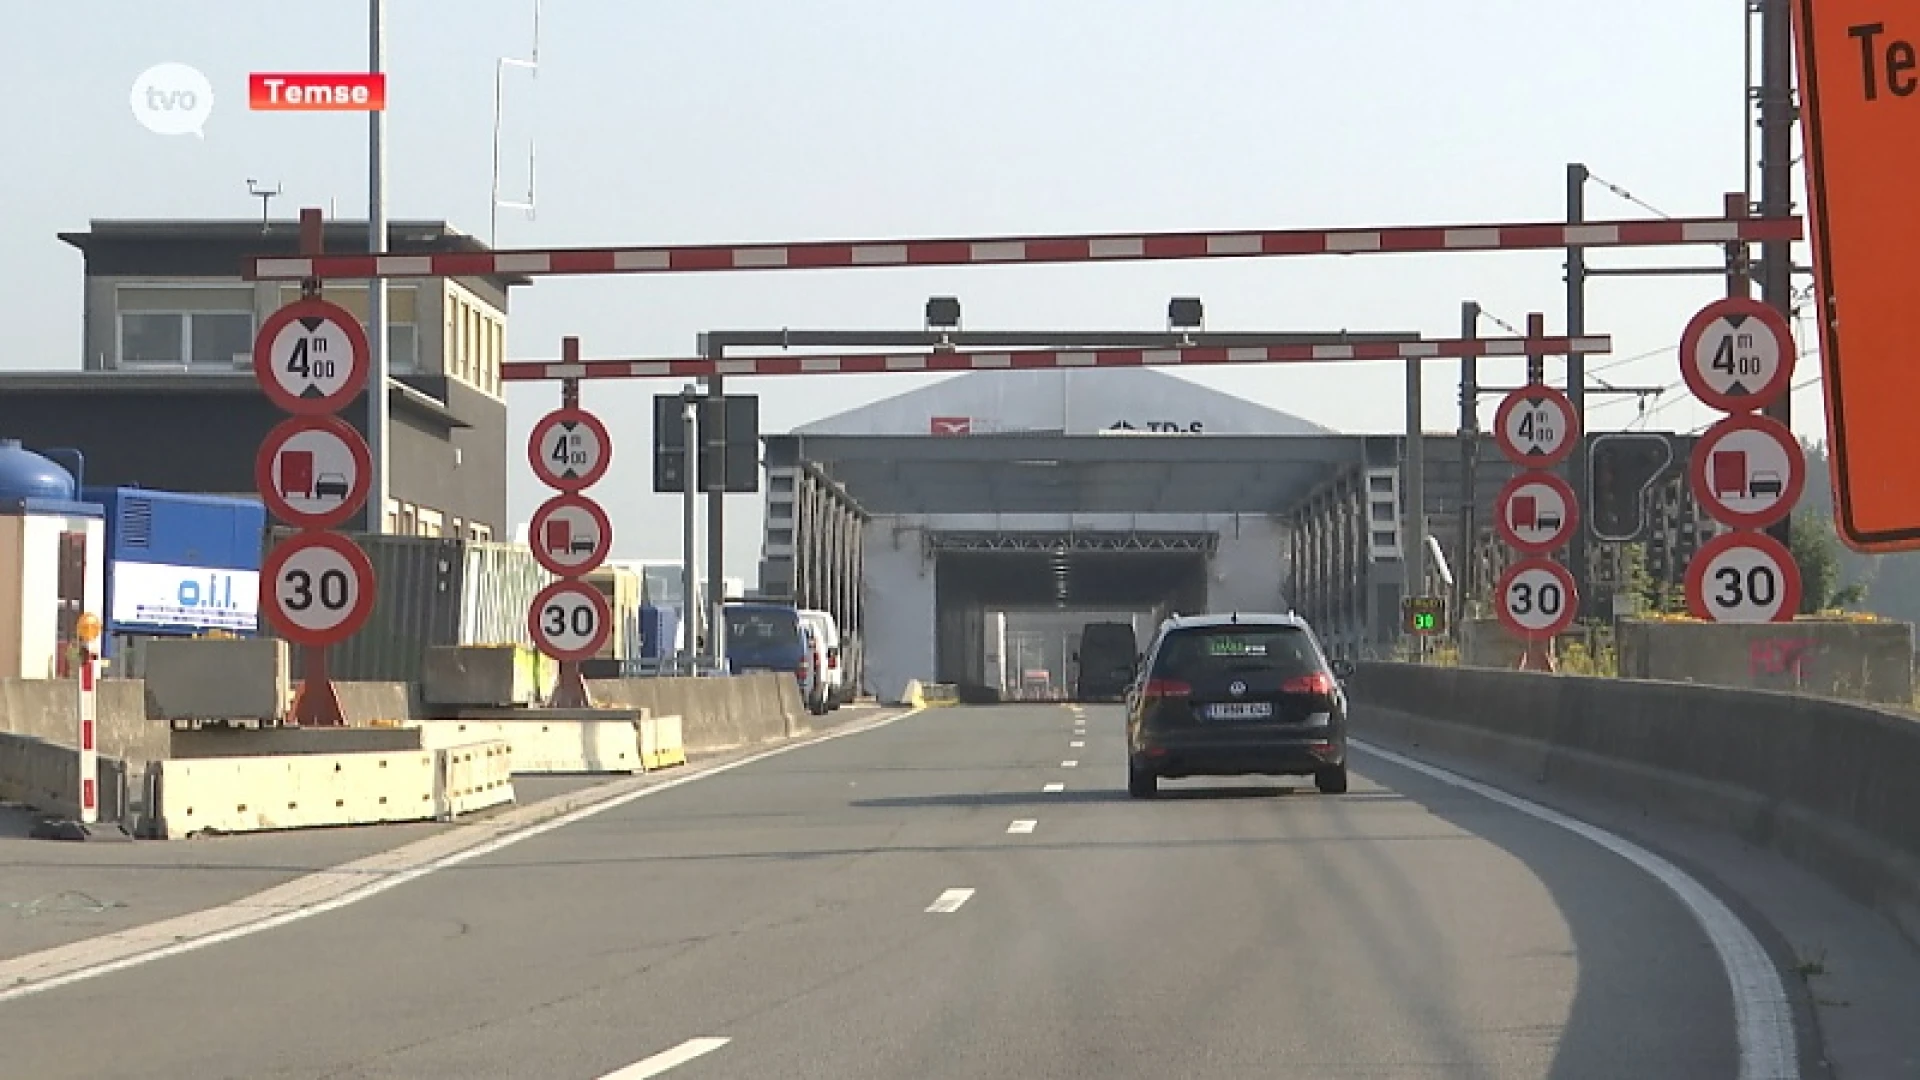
[253,211,372,728]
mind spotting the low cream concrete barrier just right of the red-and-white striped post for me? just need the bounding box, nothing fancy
[144,740,513,840]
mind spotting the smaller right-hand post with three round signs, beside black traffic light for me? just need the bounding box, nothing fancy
[1494,374,1580,671]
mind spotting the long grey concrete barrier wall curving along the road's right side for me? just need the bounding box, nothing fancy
[1352,663,1920,944]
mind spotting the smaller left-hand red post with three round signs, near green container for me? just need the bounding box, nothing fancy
[526,338,612,709]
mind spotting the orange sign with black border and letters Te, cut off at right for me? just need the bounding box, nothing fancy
[1793,0,1920,552]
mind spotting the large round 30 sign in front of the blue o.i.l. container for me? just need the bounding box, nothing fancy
[259,532,374,648]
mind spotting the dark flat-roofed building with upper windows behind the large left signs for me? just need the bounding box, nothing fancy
[0,221,526,540]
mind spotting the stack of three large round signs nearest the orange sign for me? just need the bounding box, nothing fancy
[1680,296,1807,623]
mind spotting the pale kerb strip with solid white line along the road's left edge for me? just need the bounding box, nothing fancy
[0,709,925,1005]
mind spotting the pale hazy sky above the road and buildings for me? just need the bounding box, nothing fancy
[0,0,1824,580]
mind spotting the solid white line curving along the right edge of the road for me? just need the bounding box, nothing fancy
[1348,740,1799,1080]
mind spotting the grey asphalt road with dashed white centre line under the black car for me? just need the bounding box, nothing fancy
[0,705,1766,1080]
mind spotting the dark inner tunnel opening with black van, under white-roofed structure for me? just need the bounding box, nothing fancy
[927,532,1219,701]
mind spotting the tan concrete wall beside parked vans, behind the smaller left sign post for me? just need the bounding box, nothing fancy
[588,675,810,753]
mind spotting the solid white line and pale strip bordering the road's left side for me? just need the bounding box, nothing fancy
[0,709,925,1005]
